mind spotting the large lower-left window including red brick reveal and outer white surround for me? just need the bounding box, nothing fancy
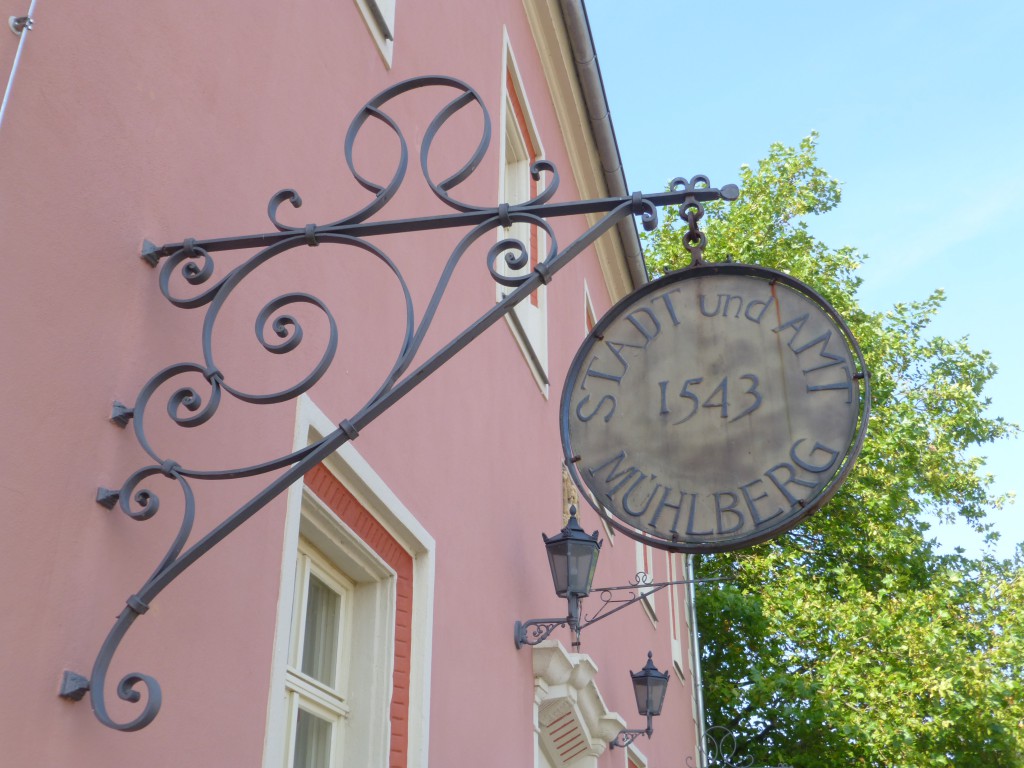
[262,395,435,768]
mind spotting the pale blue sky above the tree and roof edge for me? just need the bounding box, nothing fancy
[587,0,1024,556]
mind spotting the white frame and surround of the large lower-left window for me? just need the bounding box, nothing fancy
[263,395,436,768]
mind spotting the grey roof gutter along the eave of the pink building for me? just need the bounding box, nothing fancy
[561,0,649,288]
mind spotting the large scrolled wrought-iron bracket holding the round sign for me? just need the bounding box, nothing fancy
[60,76,738,731]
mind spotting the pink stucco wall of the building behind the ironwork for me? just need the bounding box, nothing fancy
[0,0,693,768]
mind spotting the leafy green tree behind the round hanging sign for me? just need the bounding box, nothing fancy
[646,135,1024,768]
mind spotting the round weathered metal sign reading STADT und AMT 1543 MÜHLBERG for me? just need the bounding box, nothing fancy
[560,264,869,552]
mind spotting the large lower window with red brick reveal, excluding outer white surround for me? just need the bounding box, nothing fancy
[276,489,405,768]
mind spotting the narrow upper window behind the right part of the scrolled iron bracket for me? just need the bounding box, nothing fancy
[497,37,548,396]
